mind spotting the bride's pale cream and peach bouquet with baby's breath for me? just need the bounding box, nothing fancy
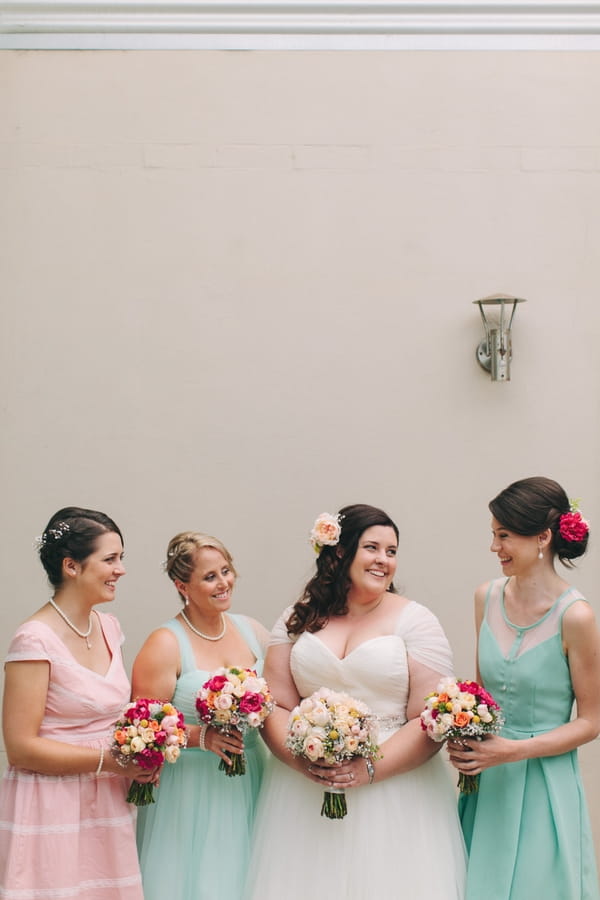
[285,688,379,819]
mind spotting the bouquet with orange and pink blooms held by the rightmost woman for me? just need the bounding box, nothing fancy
[421,678,504,794]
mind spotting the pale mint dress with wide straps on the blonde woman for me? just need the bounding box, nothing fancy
[137,614,267,900]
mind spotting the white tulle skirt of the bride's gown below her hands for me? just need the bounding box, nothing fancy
[246,754,466,900]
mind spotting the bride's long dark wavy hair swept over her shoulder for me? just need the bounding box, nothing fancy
[286,503,399,635]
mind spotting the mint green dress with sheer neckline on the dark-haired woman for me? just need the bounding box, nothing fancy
[460,578,600,900]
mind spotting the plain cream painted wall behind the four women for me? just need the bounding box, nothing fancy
[0,51,600,852]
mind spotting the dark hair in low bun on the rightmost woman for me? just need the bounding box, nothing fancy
[489,476,589,568]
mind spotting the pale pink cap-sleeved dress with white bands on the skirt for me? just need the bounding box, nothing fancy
[0,613,143,900]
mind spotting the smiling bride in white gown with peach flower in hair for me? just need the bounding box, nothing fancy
[246,505,465,900]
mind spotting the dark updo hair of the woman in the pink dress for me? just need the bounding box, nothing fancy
[36,506,123,588]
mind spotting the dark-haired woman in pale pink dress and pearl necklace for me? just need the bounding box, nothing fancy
[0,507,154,900]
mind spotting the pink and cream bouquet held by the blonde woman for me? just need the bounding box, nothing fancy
[196,666,275,775]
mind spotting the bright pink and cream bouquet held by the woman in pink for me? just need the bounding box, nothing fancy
[110,699,187,806]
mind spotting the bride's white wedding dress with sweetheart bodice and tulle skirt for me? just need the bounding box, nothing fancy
[246,602,465,900]
